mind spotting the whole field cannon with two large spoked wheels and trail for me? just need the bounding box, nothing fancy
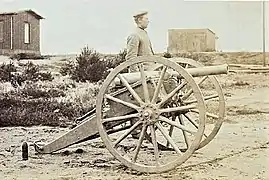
[34,56,228,173]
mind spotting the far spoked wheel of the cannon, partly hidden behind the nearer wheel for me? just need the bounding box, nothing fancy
[149,58,225,149]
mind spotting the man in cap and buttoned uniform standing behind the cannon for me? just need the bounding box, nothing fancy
[126,11,154,72]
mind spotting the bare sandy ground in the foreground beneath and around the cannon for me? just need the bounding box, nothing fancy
[0,58,269,180]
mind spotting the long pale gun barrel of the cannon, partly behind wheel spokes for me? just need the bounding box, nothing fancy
[114,64,228,85]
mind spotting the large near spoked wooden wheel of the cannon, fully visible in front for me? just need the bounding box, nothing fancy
[96,57,206,173]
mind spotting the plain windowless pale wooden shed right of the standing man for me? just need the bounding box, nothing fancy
[167,29,216,54]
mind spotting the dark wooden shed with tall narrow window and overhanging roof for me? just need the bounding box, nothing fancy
[0,10,44,55]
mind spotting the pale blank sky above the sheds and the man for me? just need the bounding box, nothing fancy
[0,0,269,54]
